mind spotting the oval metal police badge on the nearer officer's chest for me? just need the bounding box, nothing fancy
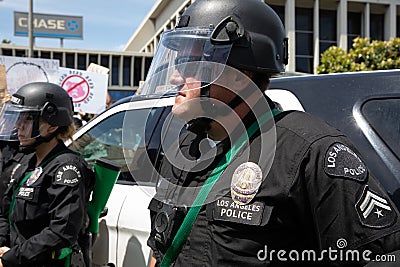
[231,162,262,205]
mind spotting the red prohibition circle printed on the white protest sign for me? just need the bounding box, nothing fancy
[61,74,90,103]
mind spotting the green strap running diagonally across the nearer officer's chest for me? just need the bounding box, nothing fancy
[161,109,280,267]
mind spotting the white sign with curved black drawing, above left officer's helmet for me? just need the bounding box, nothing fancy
[0,56,60,95]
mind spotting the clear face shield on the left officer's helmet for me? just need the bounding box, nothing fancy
[0,103,40,142]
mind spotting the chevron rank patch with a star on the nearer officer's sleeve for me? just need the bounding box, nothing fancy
[355,185,397,228]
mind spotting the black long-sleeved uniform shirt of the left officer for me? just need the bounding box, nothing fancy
[0,142,94,267]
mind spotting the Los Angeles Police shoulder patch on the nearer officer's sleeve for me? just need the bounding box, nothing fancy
[324,143,368,181]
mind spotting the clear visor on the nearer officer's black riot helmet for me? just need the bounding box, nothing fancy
[141,28,232,94]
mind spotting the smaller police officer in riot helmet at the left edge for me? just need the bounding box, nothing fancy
[0,82,94,267]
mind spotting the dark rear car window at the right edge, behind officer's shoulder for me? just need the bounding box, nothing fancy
[361,98,400,159]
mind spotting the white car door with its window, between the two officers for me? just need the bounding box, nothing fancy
[67,98,173,266]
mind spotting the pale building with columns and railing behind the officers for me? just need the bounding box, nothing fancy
[0,0,400,99]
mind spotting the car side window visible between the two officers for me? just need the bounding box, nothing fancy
[69,108,162,181]
